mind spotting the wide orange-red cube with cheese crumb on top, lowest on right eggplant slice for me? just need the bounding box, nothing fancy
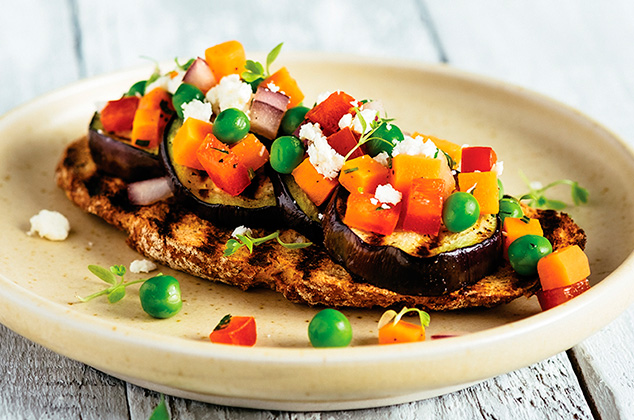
[343,192,401,235]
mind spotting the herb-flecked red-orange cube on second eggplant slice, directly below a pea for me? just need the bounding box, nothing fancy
[196,134,251,197]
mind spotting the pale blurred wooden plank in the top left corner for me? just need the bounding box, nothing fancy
[0,0,79,115]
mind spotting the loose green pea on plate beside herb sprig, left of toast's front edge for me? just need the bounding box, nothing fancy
[139,275,183,318]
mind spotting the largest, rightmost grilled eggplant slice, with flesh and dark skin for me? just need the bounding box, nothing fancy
[323,187,502,296]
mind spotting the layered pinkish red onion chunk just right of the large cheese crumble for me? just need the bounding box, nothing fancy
[250,86,290,140]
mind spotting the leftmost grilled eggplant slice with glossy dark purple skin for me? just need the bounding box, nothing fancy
[88,112,165,181]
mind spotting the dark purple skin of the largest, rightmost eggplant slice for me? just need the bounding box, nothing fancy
[323,187,502,296]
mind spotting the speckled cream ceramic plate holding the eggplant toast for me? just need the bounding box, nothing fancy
[0,55,634,410]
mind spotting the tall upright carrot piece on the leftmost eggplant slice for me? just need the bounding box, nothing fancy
[131,87,174,148]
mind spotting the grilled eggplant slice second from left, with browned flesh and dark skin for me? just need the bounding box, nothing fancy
[161,119,281,228]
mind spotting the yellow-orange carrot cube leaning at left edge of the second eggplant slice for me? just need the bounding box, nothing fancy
[172,118,213,169]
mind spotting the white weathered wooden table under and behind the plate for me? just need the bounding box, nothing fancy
[0,0,634,419]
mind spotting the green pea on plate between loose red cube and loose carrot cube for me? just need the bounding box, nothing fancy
[308,309,352,347]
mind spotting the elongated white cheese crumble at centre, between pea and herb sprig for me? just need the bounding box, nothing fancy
[299,123,345,179]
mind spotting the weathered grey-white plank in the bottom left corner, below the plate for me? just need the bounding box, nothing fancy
[0,325,128,419]
